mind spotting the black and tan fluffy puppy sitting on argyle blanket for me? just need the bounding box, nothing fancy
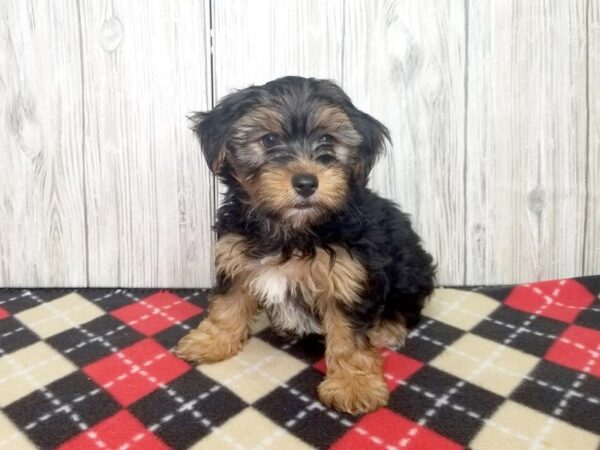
[176,77,434,414]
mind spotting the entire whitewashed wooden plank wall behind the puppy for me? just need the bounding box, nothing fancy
[0,0,600,287]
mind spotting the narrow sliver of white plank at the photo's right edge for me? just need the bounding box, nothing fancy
[583,0,600,275]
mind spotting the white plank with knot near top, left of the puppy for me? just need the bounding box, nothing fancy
[81,0,212,287]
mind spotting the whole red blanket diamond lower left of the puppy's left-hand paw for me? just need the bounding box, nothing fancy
[83,339,191,406]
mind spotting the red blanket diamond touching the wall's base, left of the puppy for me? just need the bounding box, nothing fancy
[112,292,203,336]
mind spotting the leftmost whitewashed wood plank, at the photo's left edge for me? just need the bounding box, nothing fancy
[0,0,86,286]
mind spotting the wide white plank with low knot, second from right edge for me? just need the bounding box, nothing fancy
[466,0,587,284]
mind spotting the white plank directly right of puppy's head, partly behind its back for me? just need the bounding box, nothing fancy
[343,0,465,284]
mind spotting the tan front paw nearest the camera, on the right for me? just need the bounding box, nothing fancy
[317,372,390,415]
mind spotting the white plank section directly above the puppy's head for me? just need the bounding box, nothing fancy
[213,0,343,94]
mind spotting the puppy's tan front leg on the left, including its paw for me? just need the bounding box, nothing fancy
[175,286,257,363]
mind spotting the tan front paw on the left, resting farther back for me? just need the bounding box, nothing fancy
[175,319,244,363]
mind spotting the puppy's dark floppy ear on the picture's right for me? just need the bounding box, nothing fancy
[350,109,391,184]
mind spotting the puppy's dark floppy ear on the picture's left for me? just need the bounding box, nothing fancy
[188,87,258,175]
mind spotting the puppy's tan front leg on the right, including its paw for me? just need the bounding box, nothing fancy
[318,304,389,414]
